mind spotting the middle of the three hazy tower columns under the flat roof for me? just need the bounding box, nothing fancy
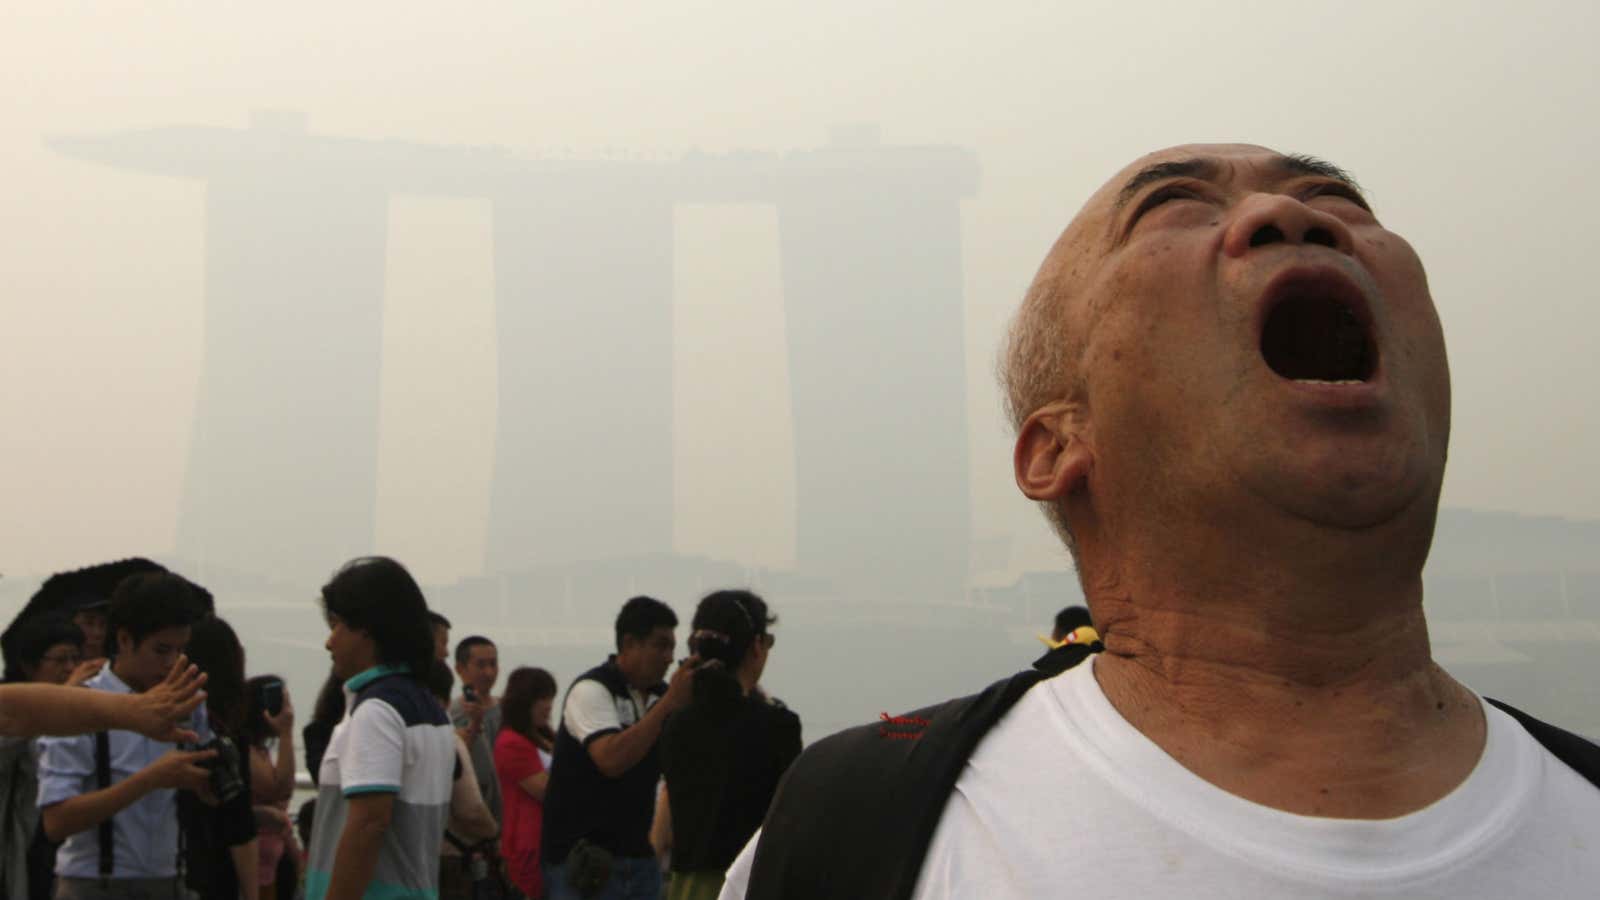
[485,173,674,573]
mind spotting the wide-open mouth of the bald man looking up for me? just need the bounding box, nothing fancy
[1261,277,1378,384]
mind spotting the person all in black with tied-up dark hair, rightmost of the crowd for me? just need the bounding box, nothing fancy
[661,591,800,900]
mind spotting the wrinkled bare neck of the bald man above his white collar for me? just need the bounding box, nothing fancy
[1086,528,1485,818]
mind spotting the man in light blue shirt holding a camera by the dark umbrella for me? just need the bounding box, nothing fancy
[38,572,218,900]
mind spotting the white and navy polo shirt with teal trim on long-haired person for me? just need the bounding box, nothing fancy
[306,666,456,900]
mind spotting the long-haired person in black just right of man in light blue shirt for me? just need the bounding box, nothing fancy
[178,615,261,900]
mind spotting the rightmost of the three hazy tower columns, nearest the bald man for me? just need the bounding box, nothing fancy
[779,167,971,601]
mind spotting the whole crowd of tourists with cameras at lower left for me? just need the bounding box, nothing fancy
[0,557,800,900]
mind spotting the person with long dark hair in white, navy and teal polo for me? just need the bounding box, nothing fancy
[306,556,456,900]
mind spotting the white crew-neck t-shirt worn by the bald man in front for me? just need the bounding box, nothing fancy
[722,665,1600,900]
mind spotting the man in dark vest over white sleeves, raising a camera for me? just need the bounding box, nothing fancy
[541,597,696,900]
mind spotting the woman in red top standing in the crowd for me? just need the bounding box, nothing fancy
[494,666,555,900]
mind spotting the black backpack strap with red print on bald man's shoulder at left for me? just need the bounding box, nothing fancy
[746,645,1093,900]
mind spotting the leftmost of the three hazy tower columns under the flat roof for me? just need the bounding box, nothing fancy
[178,159,389,581]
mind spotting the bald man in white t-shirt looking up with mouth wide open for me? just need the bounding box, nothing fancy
[723,144,1600,900]
